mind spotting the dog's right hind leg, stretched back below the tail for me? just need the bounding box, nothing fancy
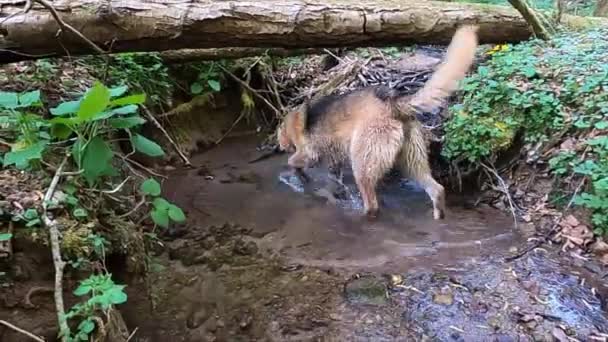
[399,120,445,220]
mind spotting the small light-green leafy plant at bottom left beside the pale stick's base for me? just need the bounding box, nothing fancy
[60,274,127,341]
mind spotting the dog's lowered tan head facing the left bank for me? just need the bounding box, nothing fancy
[277,106,317,169]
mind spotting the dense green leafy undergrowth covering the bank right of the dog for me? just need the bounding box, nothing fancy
[443,29,608,254]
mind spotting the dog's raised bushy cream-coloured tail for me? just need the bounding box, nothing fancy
[398,25,478,117]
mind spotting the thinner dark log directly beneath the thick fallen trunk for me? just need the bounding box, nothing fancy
[160,48,325,63]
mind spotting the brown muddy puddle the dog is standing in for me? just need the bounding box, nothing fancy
[166,135,524,272]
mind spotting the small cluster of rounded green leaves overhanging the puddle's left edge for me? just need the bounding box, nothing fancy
[140,178,186,228]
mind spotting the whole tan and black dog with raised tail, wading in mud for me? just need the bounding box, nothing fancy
[277,26,478,219]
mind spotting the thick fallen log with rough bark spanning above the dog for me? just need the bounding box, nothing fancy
[0,0,606,63]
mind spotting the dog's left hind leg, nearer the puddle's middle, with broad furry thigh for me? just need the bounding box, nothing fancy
[350,119,403,218]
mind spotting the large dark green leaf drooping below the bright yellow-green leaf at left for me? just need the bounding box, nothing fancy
[82,136,114,185]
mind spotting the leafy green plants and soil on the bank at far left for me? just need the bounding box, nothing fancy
[0,74,186,341]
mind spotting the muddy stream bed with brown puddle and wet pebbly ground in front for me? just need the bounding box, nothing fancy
[122,138,608,341]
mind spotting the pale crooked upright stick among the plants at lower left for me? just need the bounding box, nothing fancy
[42,155,69,341]
